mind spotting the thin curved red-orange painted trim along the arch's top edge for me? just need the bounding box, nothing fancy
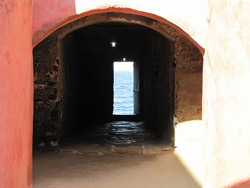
[33,7,205,55]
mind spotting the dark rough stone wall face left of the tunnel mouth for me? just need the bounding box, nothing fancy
[33,35,59,150]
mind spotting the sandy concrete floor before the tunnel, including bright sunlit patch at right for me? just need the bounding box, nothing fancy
[33,121,202,188]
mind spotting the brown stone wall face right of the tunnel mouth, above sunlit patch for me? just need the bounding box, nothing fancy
[174,36,203,122]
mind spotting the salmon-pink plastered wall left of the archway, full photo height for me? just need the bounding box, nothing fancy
[0,0,33,188]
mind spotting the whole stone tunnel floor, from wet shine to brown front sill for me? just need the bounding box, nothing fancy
[60,121,171,154]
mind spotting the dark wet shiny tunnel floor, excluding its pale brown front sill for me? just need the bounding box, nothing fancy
[65,121,160,147]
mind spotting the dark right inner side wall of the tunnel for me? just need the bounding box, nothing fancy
[141,31,175,142]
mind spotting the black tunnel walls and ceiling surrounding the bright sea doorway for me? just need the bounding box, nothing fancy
[59,23,174,147]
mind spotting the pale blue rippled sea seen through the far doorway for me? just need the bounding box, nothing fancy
[113,70,134,115]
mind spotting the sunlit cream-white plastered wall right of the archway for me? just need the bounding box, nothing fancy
[203,0,250,188]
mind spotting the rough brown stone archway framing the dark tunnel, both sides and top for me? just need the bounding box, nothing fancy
[34,12,202,151]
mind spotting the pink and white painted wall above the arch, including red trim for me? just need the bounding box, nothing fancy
[33,0,205,54]
